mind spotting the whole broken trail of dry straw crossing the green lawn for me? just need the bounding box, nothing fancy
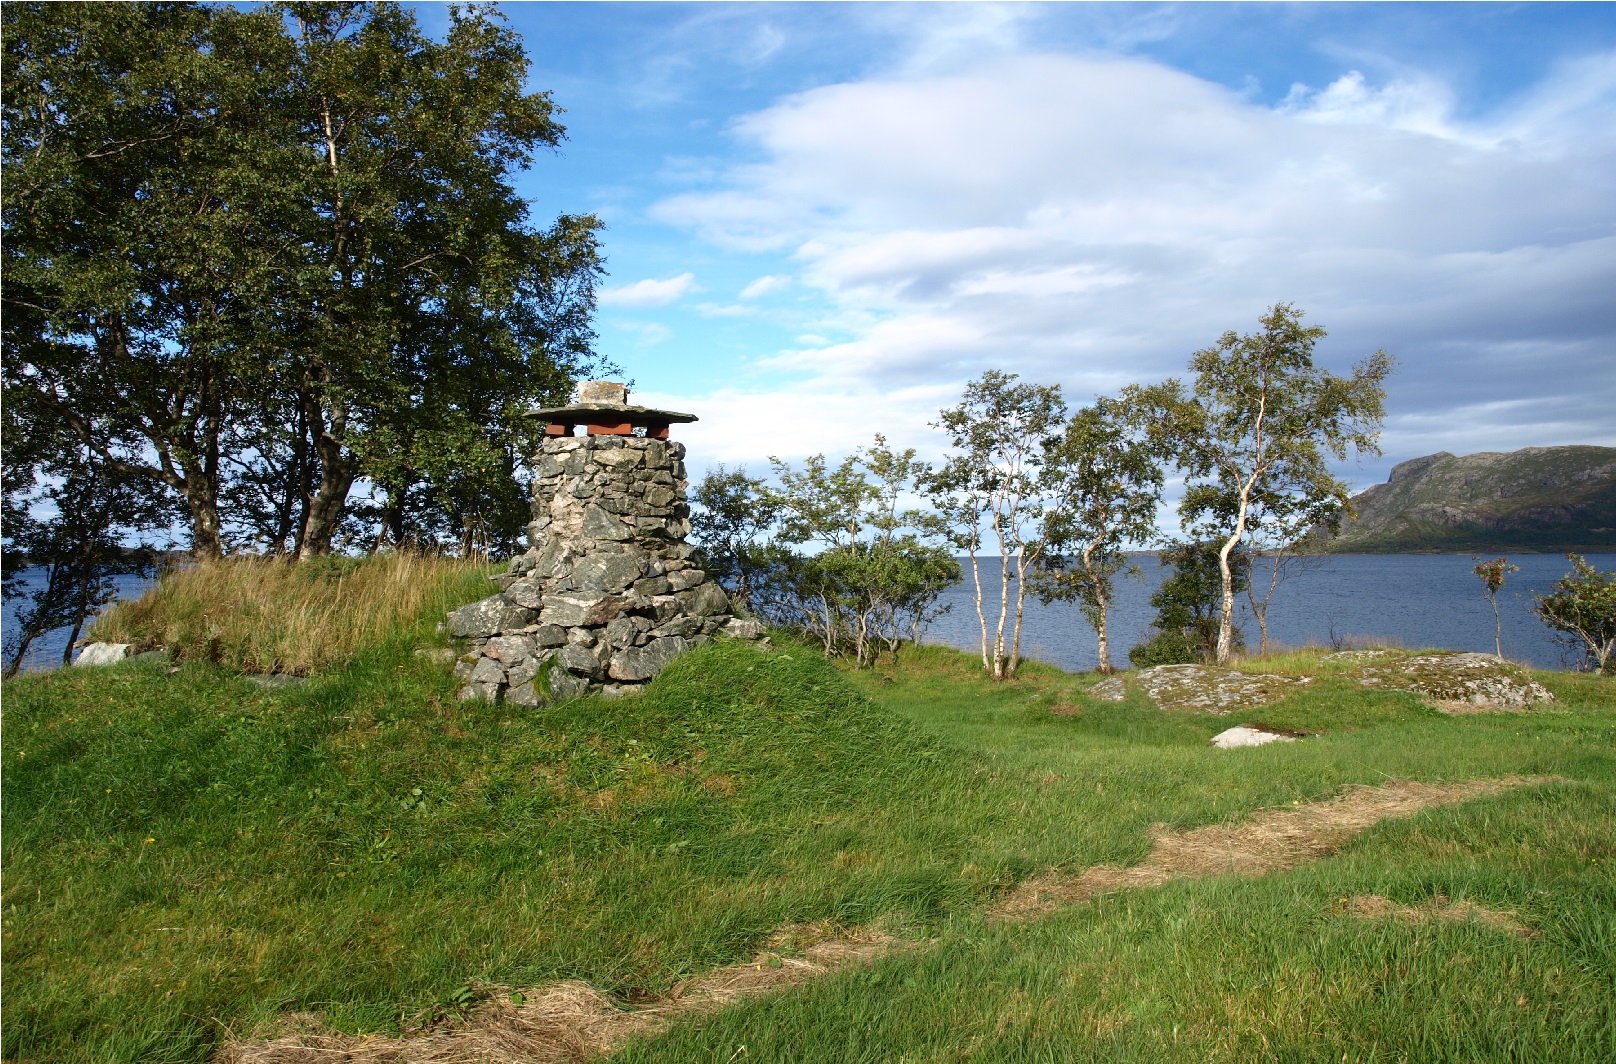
[215,776,1555,1064]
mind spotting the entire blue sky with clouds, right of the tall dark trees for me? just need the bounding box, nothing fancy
[417,3,1616,487]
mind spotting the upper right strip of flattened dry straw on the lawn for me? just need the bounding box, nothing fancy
[989,776,1553,920]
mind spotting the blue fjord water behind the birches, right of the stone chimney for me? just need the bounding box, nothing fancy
[924,553,1616,671]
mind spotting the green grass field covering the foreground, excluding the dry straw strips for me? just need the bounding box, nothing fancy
[0,559,1616,1062]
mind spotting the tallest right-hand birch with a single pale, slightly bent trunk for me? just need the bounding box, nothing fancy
[1123,304,1393,663]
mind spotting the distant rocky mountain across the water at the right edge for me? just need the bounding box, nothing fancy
[1315,446,1616,555]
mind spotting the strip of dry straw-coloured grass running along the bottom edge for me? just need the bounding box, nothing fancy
[215,925,897,1064]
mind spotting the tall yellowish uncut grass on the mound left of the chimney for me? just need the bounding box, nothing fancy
[90,553,493,676]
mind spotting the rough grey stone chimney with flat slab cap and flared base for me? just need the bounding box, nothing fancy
[449,380,763,705]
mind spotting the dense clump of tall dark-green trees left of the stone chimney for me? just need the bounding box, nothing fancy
[0,3,601,556]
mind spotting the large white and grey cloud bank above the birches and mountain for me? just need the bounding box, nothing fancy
[656,47,1616,461]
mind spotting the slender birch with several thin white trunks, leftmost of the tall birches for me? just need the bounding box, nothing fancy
[924,370,1067,679]
